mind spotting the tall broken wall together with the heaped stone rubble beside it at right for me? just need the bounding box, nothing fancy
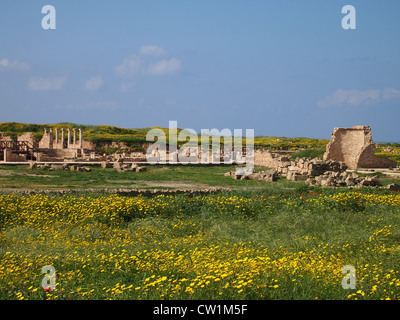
[245,126,397,187]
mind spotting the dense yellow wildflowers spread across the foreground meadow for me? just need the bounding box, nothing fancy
[0,192,400,300]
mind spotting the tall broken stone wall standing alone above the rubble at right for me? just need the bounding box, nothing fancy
[323,126,397,168]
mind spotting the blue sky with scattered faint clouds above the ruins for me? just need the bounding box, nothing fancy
[0,0,400,141]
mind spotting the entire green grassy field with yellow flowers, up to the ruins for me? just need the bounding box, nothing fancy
[0,166,400,300]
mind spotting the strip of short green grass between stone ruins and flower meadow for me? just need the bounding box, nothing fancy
[0,165,399,191]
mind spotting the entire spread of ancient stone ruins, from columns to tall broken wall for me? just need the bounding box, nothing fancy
[0,126,396,187]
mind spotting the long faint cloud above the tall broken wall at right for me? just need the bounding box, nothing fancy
[317,88,400,108]
